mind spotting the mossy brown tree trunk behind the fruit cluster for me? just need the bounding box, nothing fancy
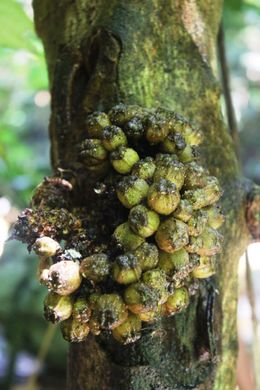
[34,0,259,390]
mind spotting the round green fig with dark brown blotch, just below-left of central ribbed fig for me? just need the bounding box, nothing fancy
[128,205,160,238]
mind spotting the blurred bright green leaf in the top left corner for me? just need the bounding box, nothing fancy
[0,0,37,54]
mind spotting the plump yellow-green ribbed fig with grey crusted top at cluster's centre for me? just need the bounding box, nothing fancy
[147,179,180,215]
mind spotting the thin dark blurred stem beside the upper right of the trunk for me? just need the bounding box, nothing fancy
[218,23,240,159]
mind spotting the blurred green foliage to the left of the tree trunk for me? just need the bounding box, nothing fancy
[0,0,67,389]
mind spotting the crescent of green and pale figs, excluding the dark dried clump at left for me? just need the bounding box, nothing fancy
[30,104,224,344]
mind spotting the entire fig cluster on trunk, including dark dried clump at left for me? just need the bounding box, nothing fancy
[14,104,223,344]
